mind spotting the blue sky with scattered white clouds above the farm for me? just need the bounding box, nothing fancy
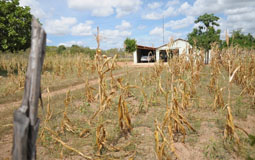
[20,0,255,49]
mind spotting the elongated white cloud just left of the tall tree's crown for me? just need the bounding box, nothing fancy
[165,16,195,29]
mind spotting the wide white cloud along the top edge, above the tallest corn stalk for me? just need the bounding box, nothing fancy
[67,0,142,17]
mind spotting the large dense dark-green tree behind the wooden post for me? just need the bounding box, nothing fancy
[0,0,32,52]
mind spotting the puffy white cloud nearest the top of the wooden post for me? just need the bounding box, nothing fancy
[45,17,77,35]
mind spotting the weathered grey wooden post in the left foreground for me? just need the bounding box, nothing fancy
[12,17,46,160]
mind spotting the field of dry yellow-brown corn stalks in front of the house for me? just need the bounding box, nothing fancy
[0,42,255,160]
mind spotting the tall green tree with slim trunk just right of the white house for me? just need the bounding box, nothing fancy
[188,13,221,64]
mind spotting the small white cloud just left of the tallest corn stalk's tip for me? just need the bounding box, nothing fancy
[71,21,93,36]
